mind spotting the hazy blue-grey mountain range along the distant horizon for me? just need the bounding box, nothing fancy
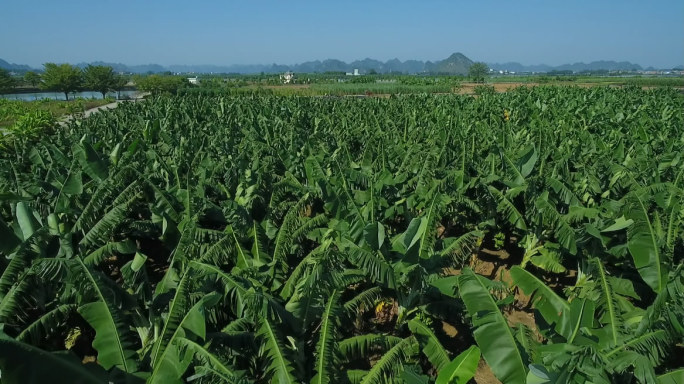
[0,53,680,75]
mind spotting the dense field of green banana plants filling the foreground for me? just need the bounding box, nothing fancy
[0,87,684,384]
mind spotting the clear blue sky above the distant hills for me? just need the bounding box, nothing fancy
[0,0,684,68]
